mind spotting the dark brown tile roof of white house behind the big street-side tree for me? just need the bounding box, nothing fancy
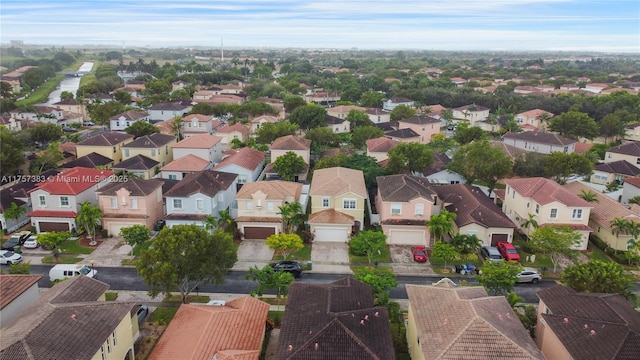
[165,170,238,197]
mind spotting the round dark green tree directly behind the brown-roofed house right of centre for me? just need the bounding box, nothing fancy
[387,142,433,174]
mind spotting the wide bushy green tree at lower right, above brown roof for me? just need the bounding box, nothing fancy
[562,259,637,303]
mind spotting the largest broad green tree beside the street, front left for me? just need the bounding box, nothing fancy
[136,225,238,303]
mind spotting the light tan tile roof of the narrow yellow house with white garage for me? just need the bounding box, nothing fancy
[309,167,368,198]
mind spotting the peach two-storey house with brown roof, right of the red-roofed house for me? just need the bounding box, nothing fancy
[97,178,164,236]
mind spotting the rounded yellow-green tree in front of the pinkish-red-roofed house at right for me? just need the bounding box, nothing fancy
[529,225,582,273]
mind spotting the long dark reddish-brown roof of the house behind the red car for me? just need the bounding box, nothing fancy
[433,184,516,229]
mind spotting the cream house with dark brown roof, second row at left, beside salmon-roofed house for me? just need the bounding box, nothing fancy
[122,133,177,166]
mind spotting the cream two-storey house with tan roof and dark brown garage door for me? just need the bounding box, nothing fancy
[235,180,306,240]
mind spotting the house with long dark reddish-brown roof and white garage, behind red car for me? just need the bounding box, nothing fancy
[433,184,516,246]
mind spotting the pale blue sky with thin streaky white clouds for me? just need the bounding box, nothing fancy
[0,0,640,53]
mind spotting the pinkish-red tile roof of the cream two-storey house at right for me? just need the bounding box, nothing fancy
[504,177,593,208]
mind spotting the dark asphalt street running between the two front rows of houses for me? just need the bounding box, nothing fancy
[31,265,576,303]
